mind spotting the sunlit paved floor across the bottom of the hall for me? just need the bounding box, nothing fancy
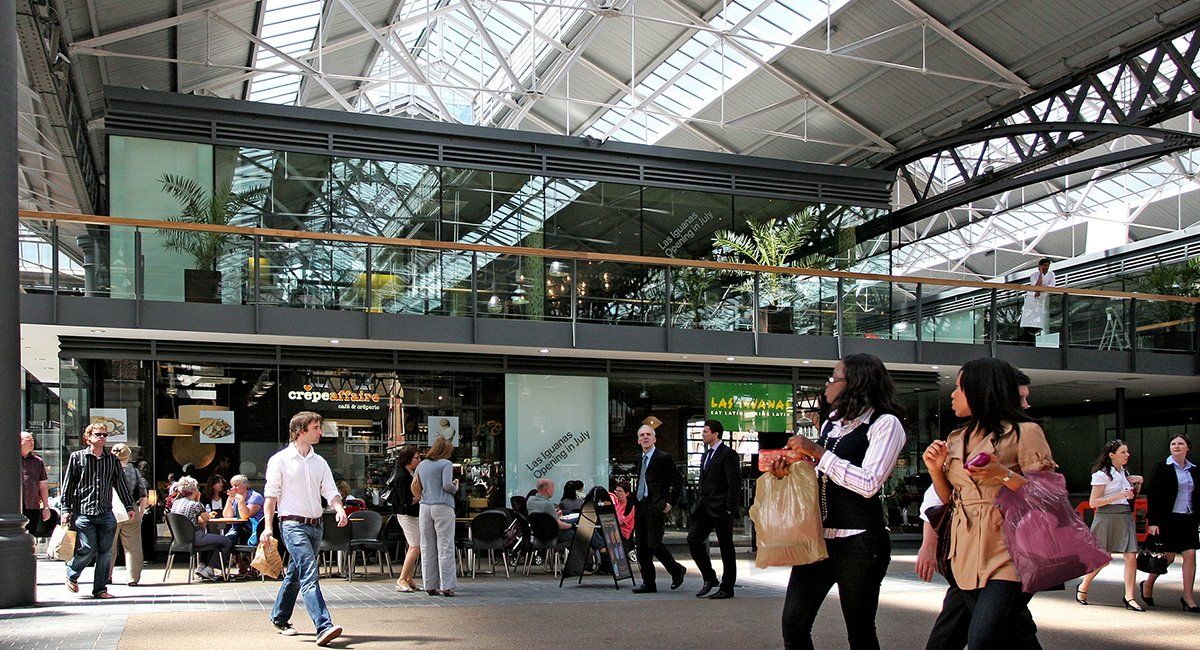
[0,550,1200,650]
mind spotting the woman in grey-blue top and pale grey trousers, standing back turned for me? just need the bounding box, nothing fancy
[412,438,458,596]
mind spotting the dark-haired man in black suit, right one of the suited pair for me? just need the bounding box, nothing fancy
[688,420,742,600]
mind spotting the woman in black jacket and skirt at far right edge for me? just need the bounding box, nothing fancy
[1140,433,1200,612]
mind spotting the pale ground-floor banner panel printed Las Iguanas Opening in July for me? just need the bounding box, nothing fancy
[504,374,608,496]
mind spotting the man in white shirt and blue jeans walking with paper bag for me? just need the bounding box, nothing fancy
[259,411,350,645]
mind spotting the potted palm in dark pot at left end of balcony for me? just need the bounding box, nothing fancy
[158,174,266,302]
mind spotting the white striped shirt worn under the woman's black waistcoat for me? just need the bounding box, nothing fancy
[817,409,907,540]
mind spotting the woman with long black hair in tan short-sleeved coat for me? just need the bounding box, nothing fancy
[924,359,1057,650]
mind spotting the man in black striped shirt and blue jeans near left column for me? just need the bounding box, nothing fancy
[61,425,137,598]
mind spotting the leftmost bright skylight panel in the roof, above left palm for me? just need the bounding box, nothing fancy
[246,0,325,104]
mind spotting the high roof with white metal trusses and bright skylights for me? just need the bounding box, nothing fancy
[18,0,1200,283]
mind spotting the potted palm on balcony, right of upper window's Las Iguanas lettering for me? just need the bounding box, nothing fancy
[713,209,829,333]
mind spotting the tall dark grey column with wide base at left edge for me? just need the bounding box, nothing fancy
[0,0,37,608]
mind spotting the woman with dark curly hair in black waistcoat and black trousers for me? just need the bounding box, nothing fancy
[772,354,905,650]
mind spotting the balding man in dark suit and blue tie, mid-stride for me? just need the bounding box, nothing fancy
[634,425,688,594]
